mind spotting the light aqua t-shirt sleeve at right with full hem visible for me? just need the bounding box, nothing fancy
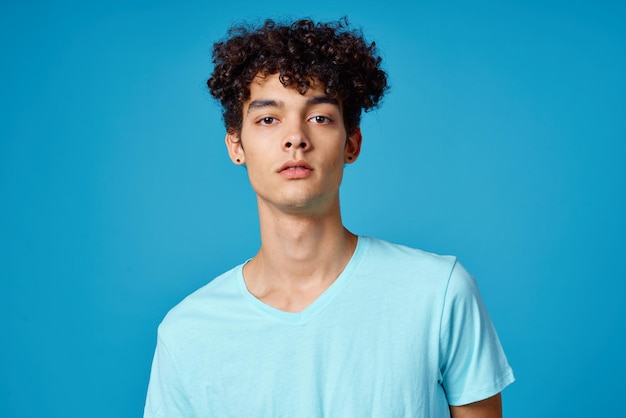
[440,262,515,406]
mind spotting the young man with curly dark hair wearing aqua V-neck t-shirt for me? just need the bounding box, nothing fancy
[145,21,514,418]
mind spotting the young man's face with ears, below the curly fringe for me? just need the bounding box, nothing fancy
[226,74,361,215]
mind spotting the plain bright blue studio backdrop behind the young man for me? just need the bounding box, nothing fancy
[0,1,626,418]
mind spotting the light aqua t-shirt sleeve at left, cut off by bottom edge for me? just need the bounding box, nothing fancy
[144,336,195,418]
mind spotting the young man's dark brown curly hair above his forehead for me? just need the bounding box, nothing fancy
[207,17,388,132]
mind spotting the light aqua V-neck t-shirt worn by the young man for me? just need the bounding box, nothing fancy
[144,237,514,418]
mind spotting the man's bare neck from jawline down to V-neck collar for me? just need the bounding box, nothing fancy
[244,196,357,311]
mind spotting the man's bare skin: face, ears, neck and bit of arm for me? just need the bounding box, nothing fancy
[225,74,502,418]
